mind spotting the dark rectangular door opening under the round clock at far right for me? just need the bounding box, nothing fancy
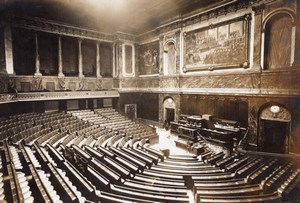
[262,120,290,154]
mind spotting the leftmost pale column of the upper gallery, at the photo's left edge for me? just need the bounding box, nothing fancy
[4,25,15,74]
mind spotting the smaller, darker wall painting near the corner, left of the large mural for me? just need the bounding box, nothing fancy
[139,41,159,75]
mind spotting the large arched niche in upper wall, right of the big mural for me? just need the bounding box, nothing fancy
[262,10,296,70]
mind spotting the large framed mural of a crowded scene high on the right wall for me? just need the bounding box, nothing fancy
[184,15,250,71]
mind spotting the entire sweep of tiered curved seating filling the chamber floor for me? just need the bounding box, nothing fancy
[0,108,300,203]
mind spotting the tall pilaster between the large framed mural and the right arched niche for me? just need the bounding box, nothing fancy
[252,5,265,70]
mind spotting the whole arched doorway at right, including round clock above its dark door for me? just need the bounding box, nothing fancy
[258,104,291,154]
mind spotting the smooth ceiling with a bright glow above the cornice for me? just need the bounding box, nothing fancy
[0,0,234,34]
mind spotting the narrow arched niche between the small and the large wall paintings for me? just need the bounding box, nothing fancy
[164,40,176,75]
